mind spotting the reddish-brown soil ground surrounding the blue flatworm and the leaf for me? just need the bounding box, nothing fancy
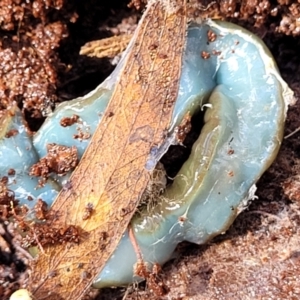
[0,0,300,300]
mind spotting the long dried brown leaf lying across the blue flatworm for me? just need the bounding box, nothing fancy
[29,0,187,300]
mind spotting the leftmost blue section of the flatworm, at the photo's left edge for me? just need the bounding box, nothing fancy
[0,106,60,208]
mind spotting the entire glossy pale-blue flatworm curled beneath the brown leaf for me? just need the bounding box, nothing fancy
[0,20,293,288]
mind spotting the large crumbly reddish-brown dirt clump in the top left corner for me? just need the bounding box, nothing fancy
[0,0,75,119]
